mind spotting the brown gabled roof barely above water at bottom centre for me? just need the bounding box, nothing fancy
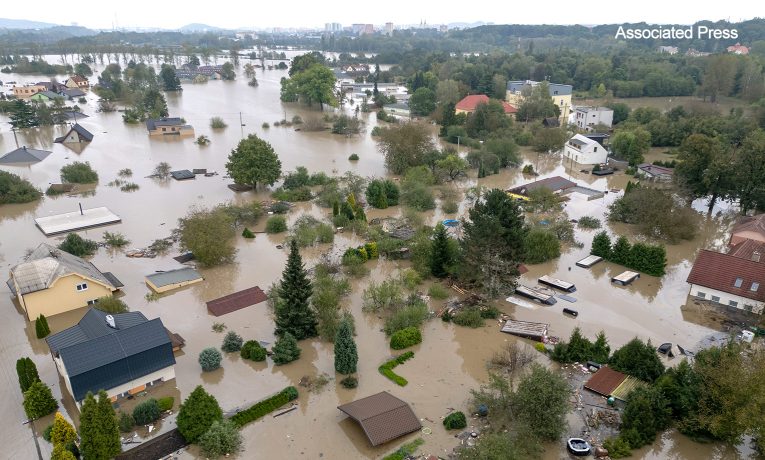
[337,391,422,446]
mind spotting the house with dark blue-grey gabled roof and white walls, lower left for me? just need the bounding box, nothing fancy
[45,308,175,407]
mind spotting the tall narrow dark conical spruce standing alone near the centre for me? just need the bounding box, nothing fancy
[274,239,318,340]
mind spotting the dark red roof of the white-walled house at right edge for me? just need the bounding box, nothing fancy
[686,249,765,302]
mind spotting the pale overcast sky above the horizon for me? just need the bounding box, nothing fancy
[5,0,754,29]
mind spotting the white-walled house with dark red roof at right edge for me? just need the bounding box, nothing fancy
[687,249,765,314]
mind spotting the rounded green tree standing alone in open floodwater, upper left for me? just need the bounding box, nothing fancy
[226,134,282,187]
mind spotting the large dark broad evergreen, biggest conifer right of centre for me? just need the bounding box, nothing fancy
[460,189,527,297]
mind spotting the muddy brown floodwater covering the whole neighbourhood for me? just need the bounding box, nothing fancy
[0,58,752,459]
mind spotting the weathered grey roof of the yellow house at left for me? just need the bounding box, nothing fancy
[11,243,122,295]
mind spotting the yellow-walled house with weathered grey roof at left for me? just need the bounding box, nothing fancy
[6,243,122,321]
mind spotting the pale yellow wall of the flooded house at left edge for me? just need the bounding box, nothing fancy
[19,274,115,321]
